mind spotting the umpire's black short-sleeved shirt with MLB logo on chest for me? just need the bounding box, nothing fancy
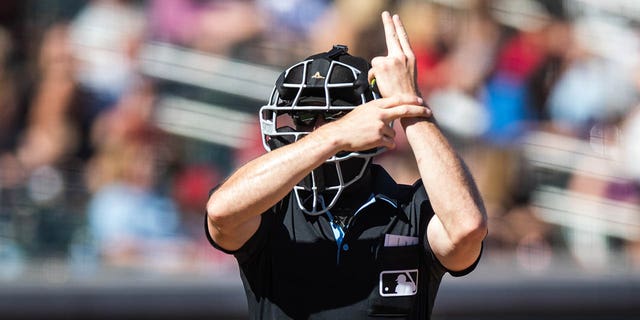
[205,165,477,319]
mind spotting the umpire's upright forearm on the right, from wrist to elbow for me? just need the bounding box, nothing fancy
[405,119,486,245]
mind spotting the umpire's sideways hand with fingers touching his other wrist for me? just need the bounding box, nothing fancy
[312,95,431,151]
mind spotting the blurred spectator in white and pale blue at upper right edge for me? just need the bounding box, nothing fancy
[547,17,640,134]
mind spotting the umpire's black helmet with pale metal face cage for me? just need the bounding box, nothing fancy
[260,45,384,215]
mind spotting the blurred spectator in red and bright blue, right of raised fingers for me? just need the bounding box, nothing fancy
[484,0,571,149]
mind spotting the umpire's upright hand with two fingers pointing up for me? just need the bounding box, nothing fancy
[369,11,420,101]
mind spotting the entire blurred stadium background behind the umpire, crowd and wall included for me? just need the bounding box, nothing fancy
[0,0,640,319]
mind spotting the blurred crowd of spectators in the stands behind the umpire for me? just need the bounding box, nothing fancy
[0,0,640,278]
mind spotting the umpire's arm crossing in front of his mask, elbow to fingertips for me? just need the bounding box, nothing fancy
[207,95,430,250]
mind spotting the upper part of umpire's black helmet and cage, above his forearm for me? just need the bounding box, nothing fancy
[260,45,379,153]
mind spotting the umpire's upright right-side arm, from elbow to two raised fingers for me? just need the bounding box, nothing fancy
[369,12,487,271]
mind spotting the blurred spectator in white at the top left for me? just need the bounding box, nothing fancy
[69,0,146,116]
